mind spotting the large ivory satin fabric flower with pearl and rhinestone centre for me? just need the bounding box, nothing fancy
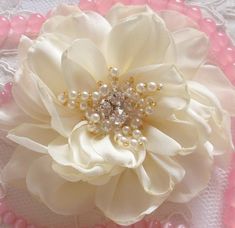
[1,4,235,225]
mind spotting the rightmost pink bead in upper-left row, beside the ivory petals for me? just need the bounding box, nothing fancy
[26,13,46,36]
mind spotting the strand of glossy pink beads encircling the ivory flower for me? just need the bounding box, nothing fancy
[0,0,235,228]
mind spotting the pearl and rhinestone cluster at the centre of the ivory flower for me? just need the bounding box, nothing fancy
[58,68,163,149]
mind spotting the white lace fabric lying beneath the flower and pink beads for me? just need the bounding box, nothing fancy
[0,0,232,228]
